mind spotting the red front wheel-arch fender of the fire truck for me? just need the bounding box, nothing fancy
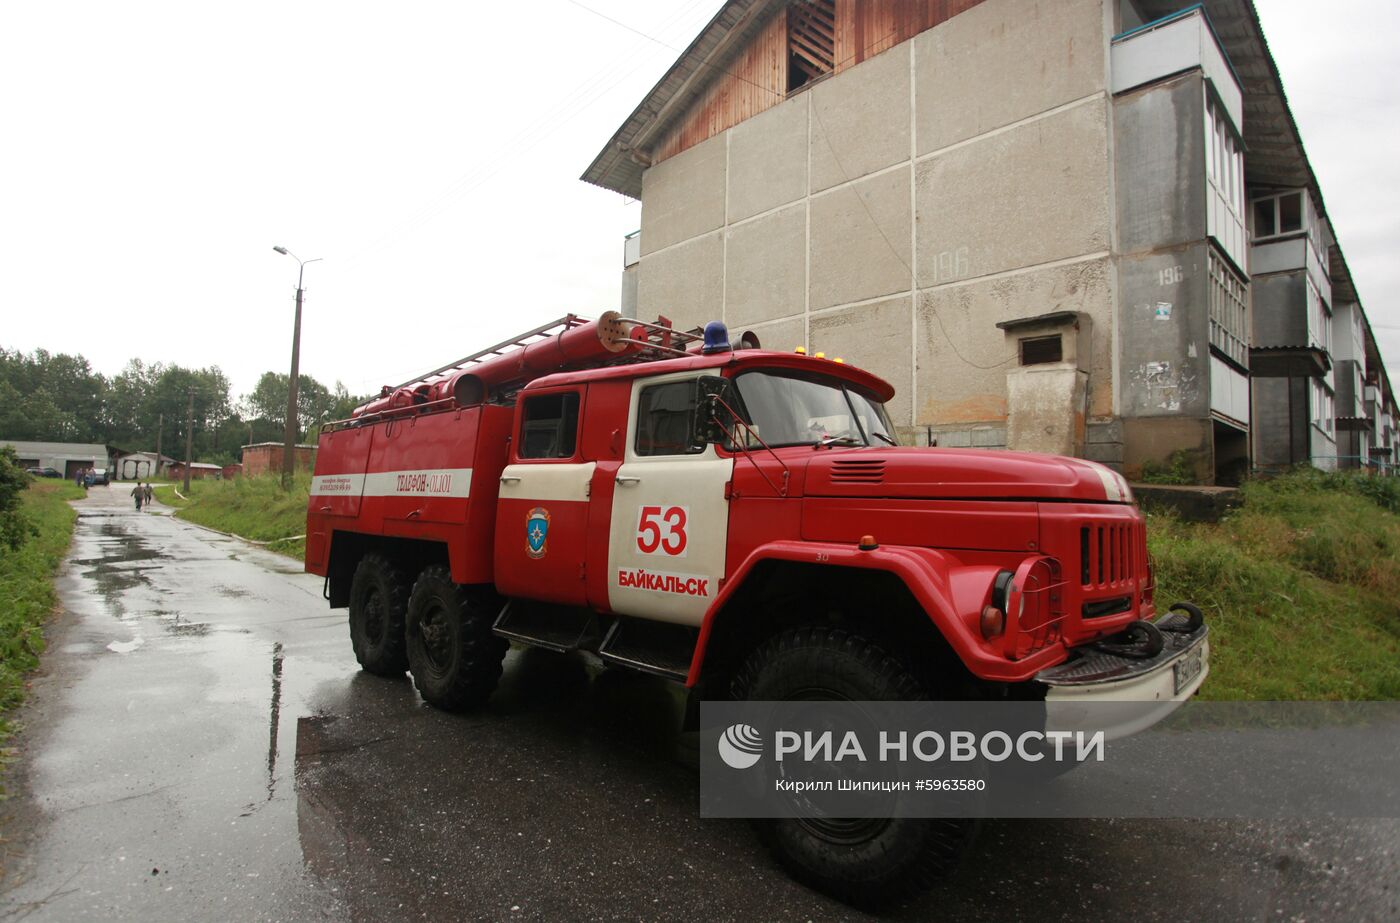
[686,542,974,686]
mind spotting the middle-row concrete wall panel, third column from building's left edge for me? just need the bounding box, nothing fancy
[809,165,910,310]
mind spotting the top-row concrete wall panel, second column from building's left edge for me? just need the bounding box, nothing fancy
[729,97,808,221]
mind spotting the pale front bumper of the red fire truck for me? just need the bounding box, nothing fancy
[1036,606,1211,738]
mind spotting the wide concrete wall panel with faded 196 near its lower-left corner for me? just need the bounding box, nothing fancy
[916,95,1112,287]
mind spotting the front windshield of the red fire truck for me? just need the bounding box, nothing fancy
[734,368,897,447]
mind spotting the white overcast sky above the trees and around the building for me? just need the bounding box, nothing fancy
[0,0,1400,395]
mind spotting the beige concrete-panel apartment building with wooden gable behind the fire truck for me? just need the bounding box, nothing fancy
[584,0,1394,483]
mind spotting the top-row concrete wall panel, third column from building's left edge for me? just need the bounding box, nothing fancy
[812,46,909,192]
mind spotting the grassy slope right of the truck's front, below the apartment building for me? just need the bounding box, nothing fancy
[1148,471,1400,700]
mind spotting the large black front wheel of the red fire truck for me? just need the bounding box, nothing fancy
[732,627,977,906]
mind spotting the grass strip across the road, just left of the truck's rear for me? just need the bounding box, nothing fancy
[155,472,311,560]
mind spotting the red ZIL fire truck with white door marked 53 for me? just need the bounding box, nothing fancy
[307,312,1208,899]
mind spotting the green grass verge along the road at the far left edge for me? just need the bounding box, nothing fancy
[0,479,83,740]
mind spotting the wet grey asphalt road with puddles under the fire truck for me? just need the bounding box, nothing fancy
[0,486,1400,922]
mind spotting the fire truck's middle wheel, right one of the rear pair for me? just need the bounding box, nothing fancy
[407,564,510,712]
